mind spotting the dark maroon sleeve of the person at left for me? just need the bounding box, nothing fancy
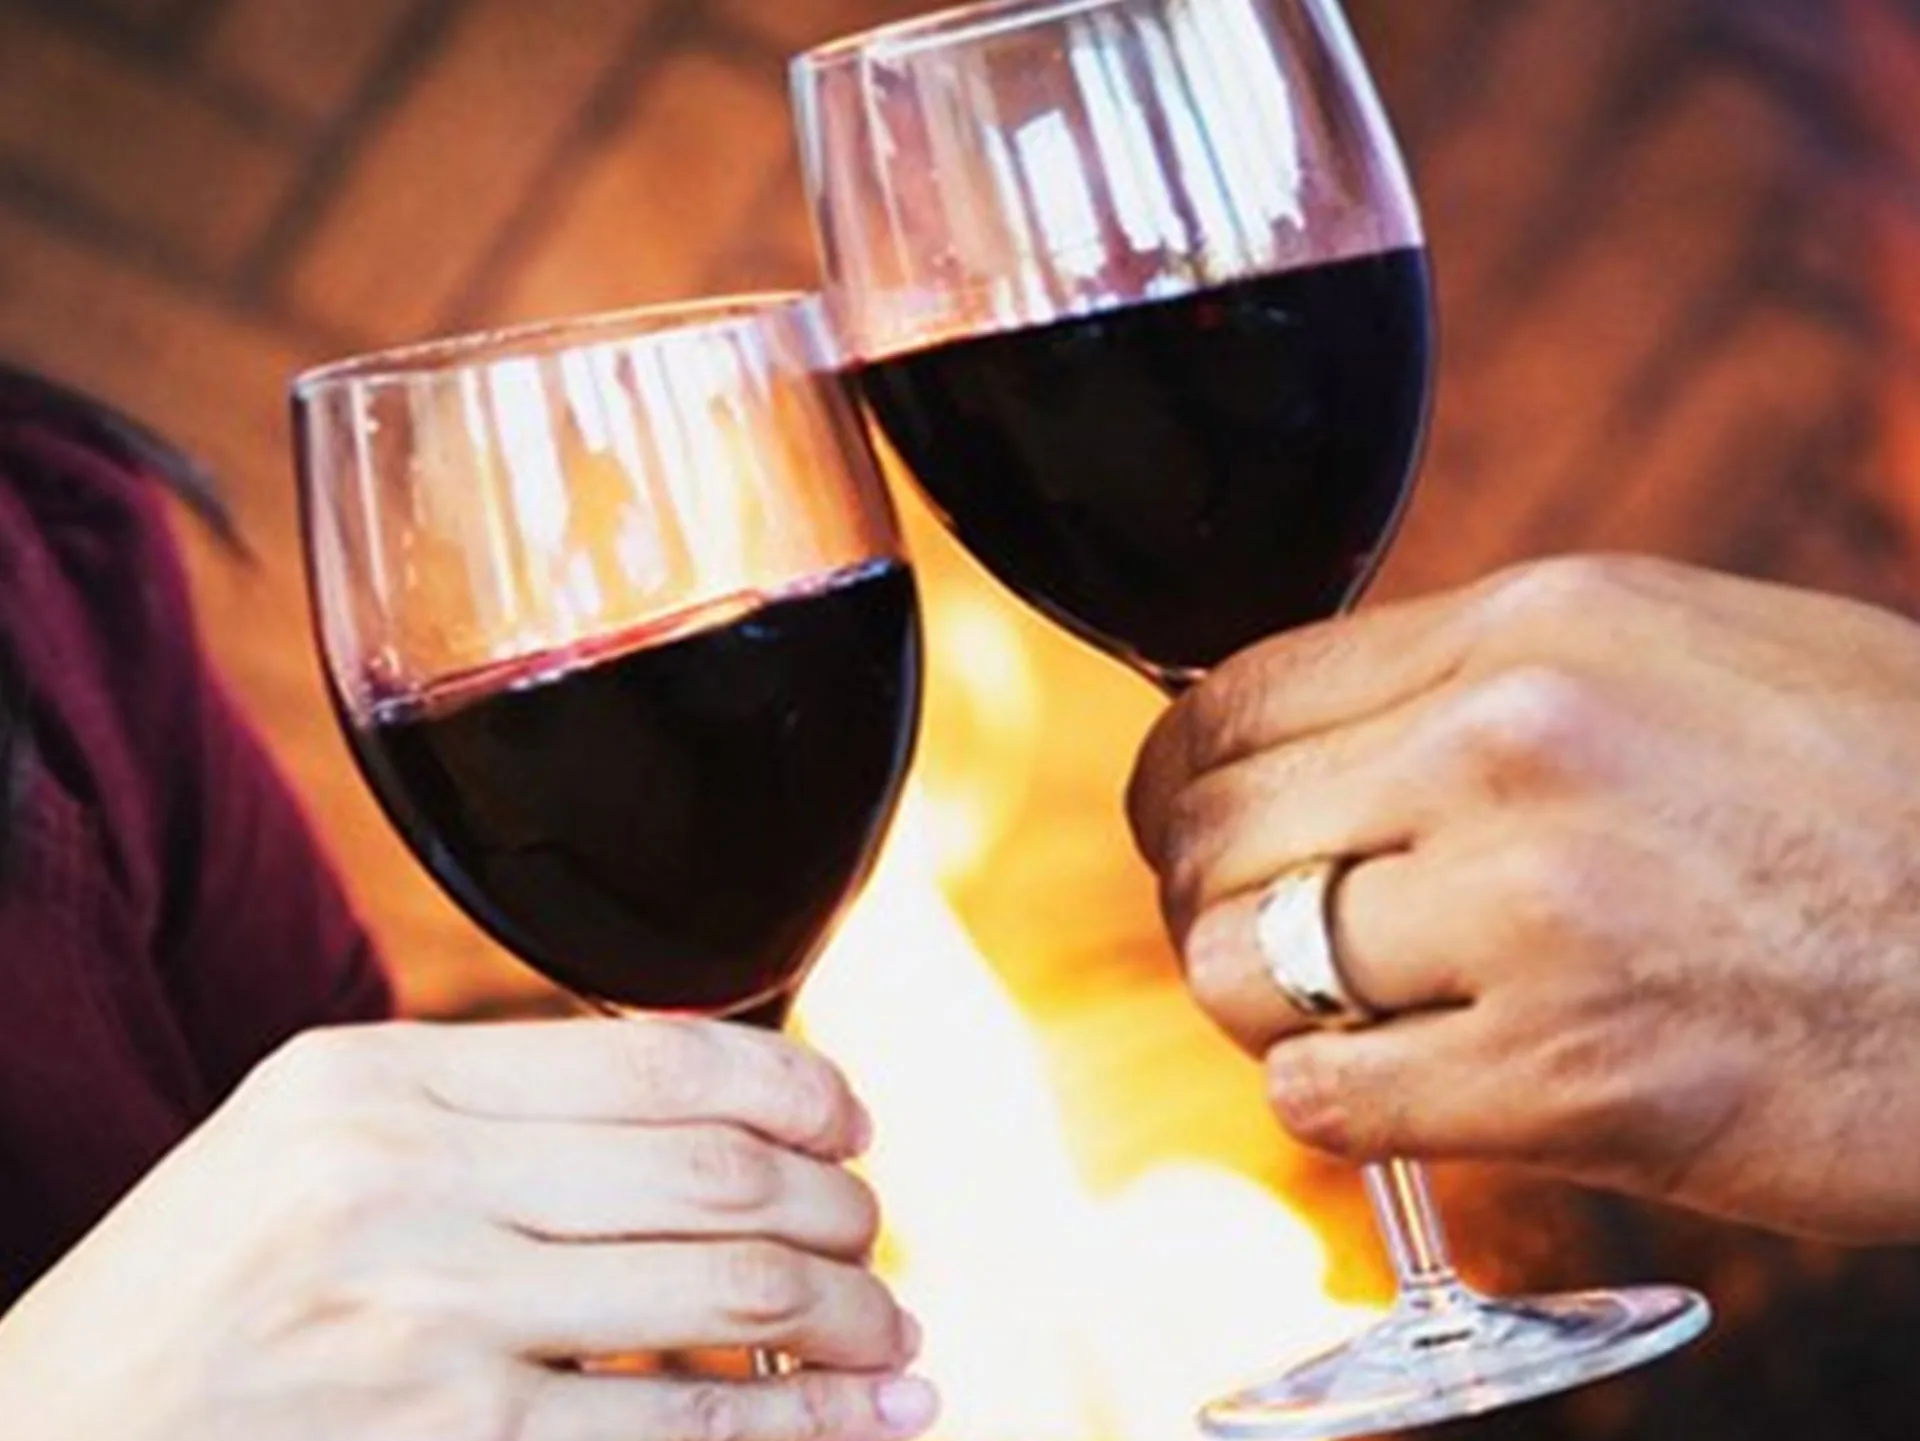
[0,393,390,1311]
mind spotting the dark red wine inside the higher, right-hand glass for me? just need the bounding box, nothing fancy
[854,249,1432,679]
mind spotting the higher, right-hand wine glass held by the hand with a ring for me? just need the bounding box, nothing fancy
[793,0,1709,1439]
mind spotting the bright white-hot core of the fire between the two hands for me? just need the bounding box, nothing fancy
[801,604,1382,1441]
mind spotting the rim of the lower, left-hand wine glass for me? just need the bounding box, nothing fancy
[294,290,820,397]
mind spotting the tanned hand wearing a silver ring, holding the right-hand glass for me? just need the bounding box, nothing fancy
[1131,558,1920,1241]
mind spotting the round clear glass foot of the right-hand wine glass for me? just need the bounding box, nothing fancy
[1200,1286,1713,1441]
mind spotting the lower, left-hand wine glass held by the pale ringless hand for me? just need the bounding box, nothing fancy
[294,295,922,1374]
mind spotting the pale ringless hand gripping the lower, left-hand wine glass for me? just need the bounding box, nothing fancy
[0,1021,933,1441]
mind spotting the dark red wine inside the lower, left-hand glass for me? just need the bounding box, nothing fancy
[349,562,920,1013]
